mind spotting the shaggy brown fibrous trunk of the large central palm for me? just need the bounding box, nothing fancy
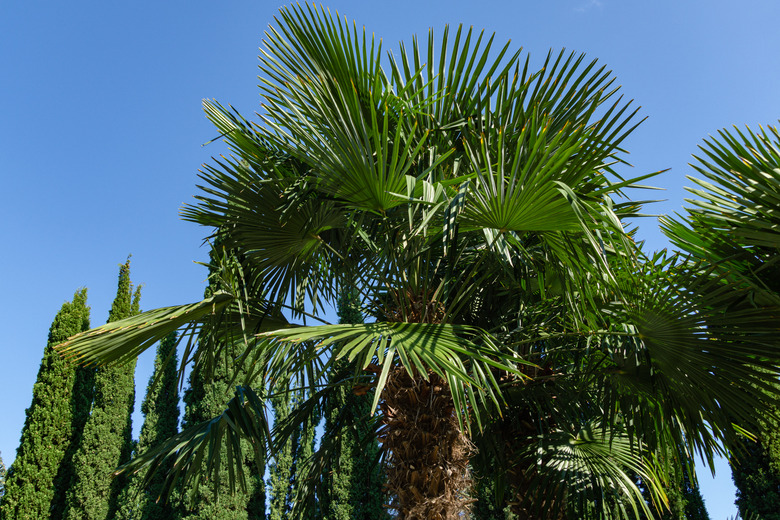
[380,367,472,520]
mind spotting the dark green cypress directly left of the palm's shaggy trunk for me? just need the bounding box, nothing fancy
[320,291,387,520]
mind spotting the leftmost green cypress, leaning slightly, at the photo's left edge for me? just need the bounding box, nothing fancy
[0,289,93,520]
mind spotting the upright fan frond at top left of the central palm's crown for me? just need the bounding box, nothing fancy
[261,4,450,212]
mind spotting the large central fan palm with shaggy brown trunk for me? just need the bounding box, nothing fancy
[61,7,777,519]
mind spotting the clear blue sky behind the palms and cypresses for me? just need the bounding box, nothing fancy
[0,0,780,520]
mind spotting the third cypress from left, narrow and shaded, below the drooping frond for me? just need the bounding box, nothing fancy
[117,332,179,520]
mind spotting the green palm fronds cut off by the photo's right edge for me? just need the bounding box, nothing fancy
[662,126,780,305]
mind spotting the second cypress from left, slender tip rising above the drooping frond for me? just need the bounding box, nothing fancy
[65,258,141,520]
